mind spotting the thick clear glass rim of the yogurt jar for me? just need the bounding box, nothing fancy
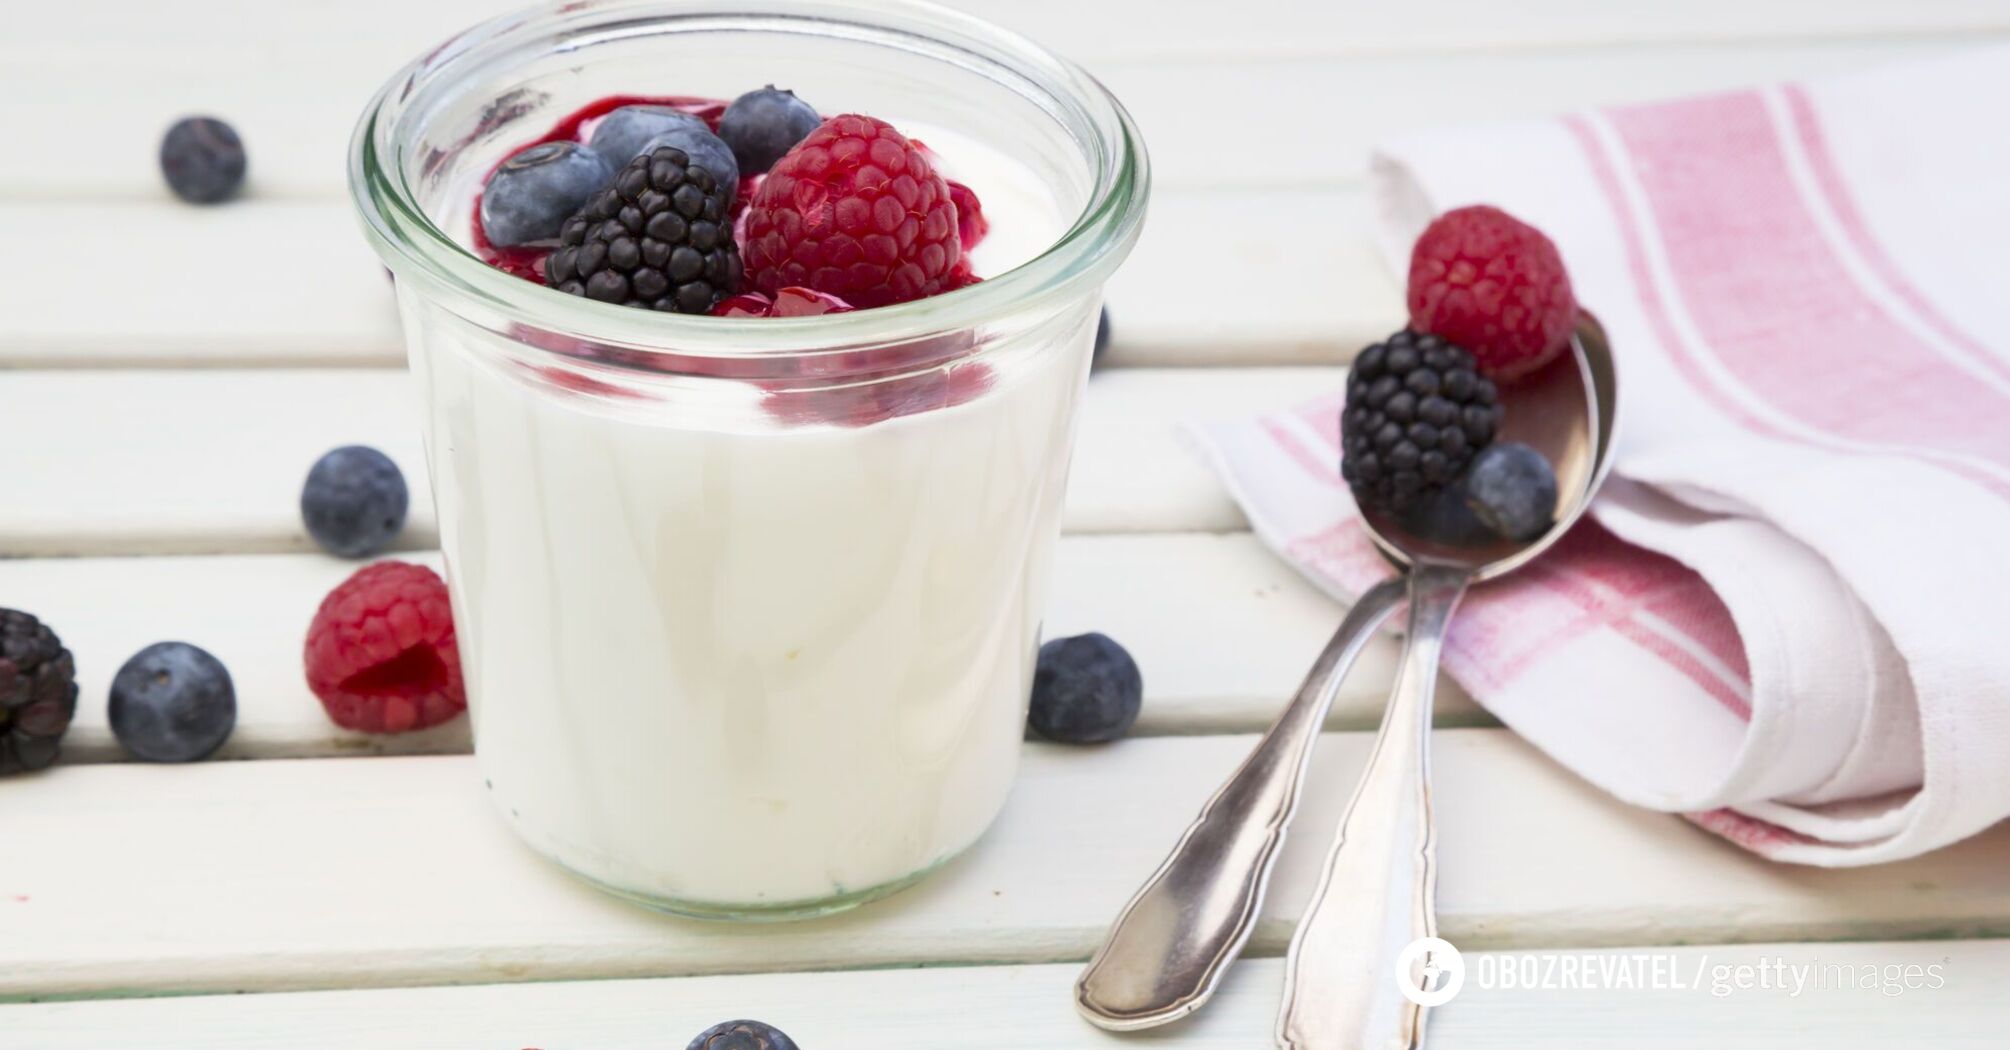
[350,0,1150,358]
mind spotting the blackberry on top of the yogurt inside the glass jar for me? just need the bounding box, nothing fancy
[545,147,740,314]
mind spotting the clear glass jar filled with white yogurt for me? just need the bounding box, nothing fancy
[350,0,1148,917]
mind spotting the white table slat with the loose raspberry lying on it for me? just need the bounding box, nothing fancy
[0,533,1489,762]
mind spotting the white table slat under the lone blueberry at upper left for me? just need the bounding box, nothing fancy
[0,35,1976,203]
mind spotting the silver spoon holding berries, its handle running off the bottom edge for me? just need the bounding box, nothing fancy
[1276,314,1618,1050]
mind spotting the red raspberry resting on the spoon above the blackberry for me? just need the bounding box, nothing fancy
[1409,205,1578,380]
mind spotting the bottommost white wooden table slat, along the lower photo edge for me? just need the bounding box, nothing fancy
[0,941,2010,1050]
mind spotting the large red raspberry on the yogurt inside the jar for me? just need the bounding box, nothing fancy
[746,115,963,308]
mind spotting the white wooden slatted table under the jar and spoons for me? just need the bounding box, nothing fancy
[0,0,2010,1050]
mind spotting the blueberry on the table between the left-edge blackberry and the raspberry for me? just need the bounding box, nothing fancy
[111,642,237,762]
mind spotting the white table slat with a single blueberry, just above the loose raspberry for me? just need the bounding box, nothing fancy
[0,368,1343,557]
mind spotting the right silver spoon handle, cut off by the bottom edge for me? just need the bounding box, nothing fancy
[1276,565,1469,1050]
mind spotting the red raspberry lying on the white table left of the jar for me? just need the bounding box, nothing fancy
[306,561,468,732]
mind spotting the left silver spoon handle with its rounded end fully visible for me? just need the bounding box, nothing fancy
[1075,579,1403,1032]
